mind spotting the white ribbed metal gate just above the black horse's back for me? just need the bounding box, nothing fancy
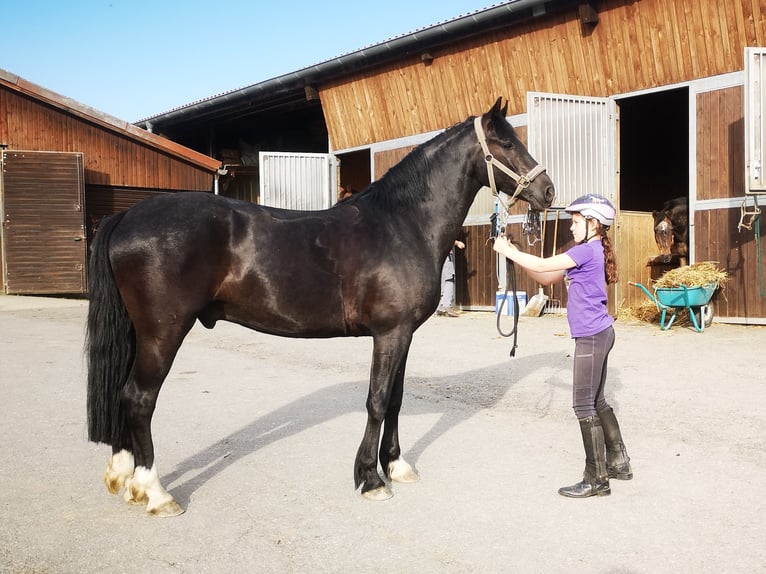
[258,152,336,210]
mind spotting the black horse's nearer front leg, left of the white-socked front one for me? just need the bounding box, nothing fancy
[354,330,412,500]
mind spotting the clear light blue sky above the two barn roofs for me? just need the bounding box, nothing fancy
[0,0,502,122]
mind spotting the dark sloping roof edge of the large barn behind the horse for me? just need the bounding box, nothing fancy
[136,0,582,130]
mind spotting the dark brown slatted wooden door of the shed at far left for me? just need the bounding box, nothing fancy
[0,151,87,294]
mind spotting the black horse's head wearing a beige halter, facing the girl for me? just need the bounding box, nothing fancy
[474,98,556,211]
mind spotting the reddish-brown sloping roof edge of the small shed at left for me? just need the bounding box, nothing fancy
[0,68,221,173]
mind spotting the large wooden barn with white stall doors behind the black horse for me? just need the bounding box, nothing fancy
[139,0,766,323]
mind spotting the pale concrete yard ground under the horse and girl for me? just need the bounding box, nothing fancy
[0,296,766,574]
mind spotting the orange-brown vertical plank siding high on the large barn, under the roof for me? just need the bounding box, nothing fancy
[319,0,766,149]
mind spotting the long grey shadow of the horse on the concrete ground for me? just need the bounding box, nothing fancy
[163,352,570,506]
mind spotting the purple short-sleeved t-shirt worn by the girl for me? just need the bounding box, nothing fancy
[566,241,614,338]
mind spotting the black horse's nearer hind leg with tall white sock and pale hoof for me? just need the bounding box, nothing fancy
[121,322,193,517]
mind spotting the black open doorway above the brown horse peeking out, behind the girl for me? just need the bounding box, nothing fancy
[617,88,689,211]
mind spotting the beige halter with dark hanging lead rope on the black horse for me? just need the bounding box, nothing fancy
[473,116,545,357]
